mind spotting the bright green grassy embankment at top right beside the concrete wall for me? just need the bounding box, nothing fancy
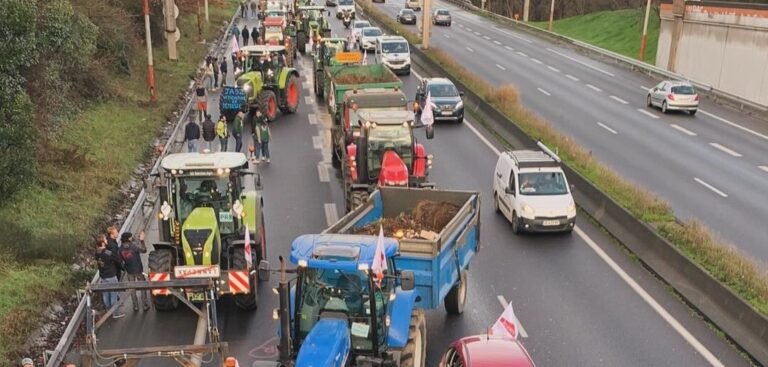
[531,7,660,64]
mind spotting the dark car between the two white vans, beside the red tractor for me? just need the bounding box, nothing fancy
[414,78,464,123]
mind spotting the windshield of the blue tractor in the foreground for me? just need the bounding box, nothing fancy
[294,269,391,351]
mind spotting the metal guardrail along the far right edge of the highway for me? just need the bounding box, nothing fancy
[445,0,768,113]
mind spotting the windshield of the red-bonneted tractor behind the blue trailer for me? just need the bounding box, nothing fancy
[367,124,413,179]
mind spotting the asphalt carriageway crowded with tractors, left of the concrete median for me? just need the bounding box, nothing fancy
[84,8,748,367]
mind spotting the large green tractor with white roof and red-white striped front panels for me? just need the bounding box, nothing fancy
[148,152,266,311]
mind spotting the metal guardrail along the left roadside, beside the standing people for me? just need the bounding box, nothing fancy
[45,8,238,367]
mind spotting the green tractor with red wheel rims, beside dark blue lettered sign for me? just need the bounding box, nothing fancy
[236,45,301,121]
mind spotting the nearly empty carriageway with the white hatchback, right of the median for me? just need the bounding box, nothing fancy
[366,0,768,262]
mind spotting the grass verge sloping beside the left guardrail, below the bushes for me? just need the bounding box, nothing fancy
[0,1,237,366]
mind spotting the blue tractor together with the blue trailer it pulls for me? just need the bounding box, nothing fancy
[260,187,480,367]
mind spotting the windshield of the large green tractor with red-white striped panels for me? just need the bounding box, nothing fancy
[173,176,237,234]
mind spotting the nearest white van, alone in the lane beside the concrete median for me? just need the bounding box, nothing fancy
[493,143,576,233]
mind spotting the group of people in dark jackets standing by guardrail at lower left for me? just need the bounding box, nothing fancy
[94,227,151,319]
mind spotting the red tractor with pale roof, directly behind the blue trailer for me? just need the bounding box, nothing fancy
[341,111,435,212]
